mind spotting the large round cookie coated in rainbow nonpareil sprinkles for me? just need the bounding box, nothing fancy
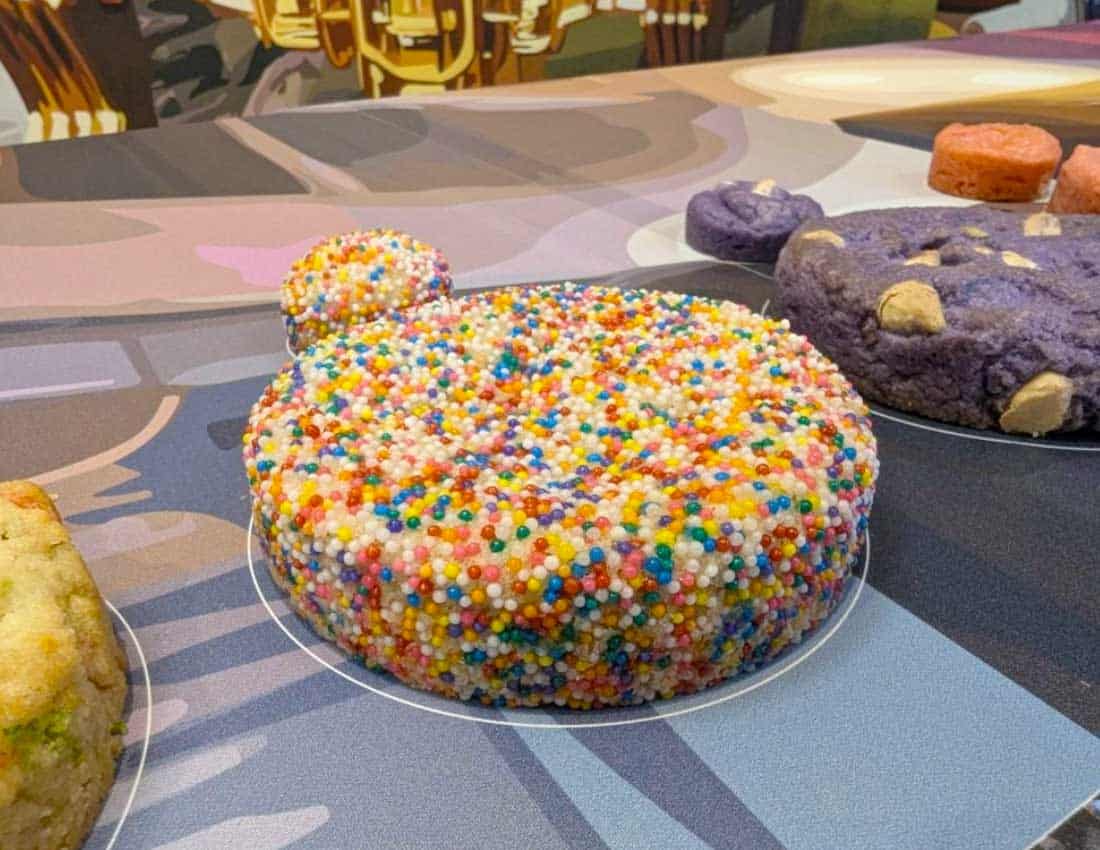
[244,285,878,708]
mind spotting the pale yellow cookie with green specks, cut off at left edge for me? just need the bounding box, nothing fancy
[0,482,127,850]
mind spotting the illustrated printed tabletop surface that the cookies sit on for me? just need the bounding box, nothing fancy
[0,26,1100,850]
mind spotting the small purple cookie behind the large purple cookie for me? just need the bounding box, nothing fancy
[685,180,823,263]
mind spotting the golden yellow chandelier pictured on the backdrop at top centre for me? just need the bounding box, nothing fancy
[251,0,710,97]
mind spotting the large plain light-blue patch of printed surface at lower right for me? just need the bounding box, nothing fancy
[669,584,1100,850]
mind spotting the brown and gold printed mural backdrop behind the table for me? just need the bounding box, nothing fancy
[0,0,1038,144]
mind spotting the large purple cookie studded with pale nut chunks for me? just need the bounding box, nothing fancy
[776,207,1100,435]
